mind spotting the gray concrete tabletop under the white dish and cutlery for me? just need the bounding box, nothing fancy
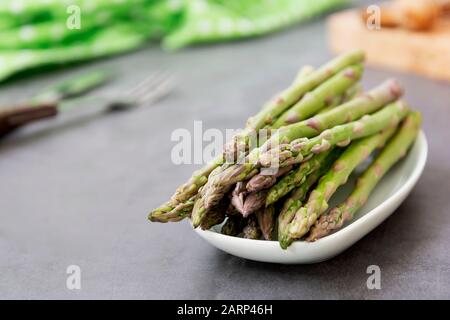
[0,17,450,299]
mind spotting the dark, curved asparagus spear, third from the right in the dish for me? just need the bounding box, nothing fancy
[278,148,344,249]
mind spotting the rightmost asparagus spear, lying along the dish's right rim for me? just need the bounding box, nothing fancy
[306,112,421,241]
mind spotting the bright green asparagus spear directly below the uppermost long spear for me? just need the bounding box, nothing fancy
[273,64,363,128]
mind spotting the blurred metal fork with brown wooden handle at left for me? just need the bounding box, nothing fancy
[0,72,175,136]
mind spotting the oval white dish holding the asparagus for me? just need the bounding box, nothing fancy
[196,131,428,264]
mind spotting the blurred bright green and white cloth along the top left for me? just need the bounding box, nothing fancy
[0,0,348,81]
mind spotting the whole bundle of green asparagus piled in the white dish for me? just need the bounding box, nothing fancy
[149,51,421,249]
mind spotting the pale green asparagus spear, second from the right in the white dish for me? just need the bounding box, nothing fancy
[289,123,397,239]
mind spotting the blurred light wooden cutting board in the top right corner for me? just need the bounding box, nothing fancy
[327,10,450,80]
